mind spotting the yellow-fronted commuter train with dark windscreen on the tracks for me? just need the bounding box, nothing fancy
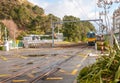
[87,31,96,45]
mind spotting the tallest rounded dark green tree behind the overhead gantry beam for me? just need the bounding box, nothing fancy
[63,16,81,42]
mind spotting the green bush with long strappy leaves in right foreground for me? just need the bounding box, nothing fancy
[77,37,120,83]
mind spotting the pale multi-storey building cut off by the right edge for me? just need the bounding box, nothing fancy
[113,7,120,42]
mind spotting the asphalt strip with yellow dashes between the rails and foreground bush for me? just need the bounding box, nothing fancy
[38,49,98,83]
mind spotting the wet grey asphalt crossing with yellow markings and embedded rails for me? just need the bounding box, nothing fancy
[0,46,99,83]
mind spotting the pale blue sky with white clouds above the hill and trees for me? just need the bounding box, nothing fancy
[28,0,120,32]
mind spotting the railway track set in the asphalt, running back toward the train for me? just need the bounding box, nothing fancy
[0,44,92,83]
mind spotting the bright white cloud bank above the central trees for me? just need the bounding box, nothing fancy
[45,0,98,19]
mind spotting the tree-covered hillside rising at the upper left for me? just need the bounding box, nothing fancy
[0,0,59,37]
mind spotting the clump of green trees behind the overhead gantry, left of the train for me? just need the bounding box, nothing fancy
[63,16,95,42]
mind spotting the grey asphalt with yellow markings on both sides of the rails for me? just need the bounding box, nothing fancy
[0,47,100,83]
